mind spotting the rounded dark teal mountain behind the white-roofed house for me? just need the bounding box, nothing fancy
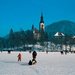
[45,20,75,37]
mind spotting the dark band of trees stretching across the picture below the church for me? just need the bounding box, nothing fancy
[0,29,75,50]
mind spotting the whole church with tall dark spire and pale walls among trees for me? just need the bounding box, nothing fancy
[32,14,45,40]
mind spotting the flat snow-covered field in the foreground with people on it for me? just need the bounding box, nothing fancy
[0,52,75,75]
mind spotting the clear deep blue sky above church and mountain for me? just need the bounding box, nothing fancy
[0,0,75,37]
